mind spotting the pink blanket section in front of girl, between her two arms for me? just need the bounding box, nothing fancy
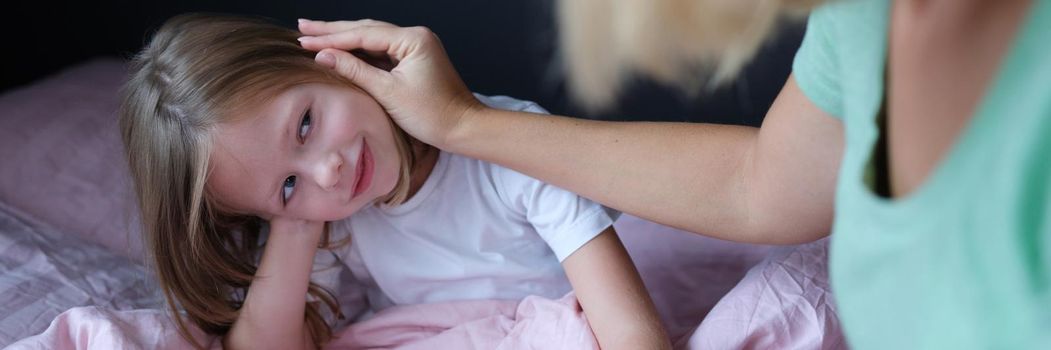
[327,293,598,350]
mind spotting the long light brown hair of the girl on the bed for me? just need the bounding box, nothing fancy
[120,14,414,347]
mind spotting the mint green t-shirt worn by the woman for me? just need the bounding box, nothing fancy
[792,0,1051,349]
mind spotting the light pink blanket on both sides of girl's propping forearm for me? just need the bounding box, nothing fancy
[9,293,598,350]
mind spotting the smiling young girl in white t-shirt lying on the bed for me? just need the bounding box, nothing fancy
[121,15,668,349]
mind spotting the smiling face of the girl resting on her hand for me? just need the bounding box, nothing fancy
[207,83,400,221]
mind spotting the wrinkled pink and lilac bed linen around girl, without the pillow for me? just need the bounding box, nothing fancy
[0,202,842,349]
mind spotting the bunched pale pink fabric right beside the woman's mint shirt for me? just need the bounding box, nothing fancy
[682,239,847,350]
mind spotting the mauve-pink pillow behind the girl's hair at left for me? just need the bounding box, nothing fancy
[0,59,142,261]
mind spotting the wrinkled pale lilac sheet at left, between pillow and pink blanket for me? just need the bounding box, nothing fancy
[0,203,163,346]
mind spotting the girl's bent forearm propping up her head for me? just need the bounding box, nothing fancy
[223,219,324,349]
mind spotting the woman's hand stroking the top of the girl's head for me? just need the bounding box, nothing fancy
[300,20,485,148]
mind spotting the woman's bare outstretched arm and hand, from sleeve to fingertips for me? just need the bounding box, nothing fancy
[300,21,843,244]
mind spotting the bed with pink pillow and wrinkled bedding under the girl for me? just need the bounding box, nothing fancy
[0,58,846,349]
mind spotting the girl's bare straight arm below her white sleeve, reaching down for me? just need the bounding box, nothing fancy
[562,226,672,350]
